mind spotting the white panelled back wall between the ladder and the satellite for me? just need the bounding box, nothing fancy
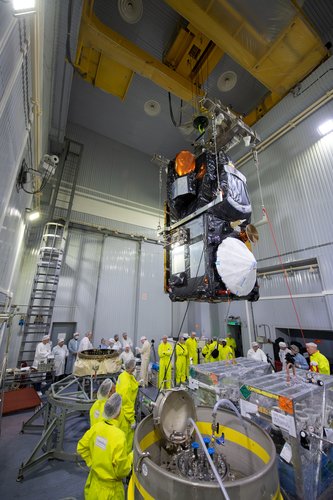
[53,229,172,346]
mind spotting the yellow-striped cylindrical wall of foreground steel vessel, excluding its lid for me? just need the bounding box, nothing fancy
[128,407,282,500]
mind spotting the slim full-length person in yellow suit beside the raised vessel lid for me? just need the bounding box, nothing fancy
[116,359,139,452]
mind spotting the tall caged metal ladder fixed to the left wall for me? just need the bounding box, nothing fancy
[18,141,83,366]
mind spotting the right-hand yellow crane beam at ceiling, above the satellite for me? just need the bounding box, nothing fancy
[164,0,327,97]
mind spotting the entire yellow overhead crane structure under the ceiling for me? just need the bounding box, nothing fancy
[75,0,327,125]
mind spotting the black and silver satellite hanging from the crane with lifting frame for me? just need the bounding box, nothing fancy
[162,98,259,302]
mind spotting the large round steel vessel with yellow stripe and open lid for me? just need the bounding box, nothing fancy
[128,391,282,500]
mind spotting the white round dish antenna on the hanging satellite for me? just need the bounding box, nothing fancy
[216,237,257,296]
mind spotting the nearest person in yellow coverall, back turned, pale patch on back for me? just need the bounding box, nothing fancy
[77,393,133,500]
